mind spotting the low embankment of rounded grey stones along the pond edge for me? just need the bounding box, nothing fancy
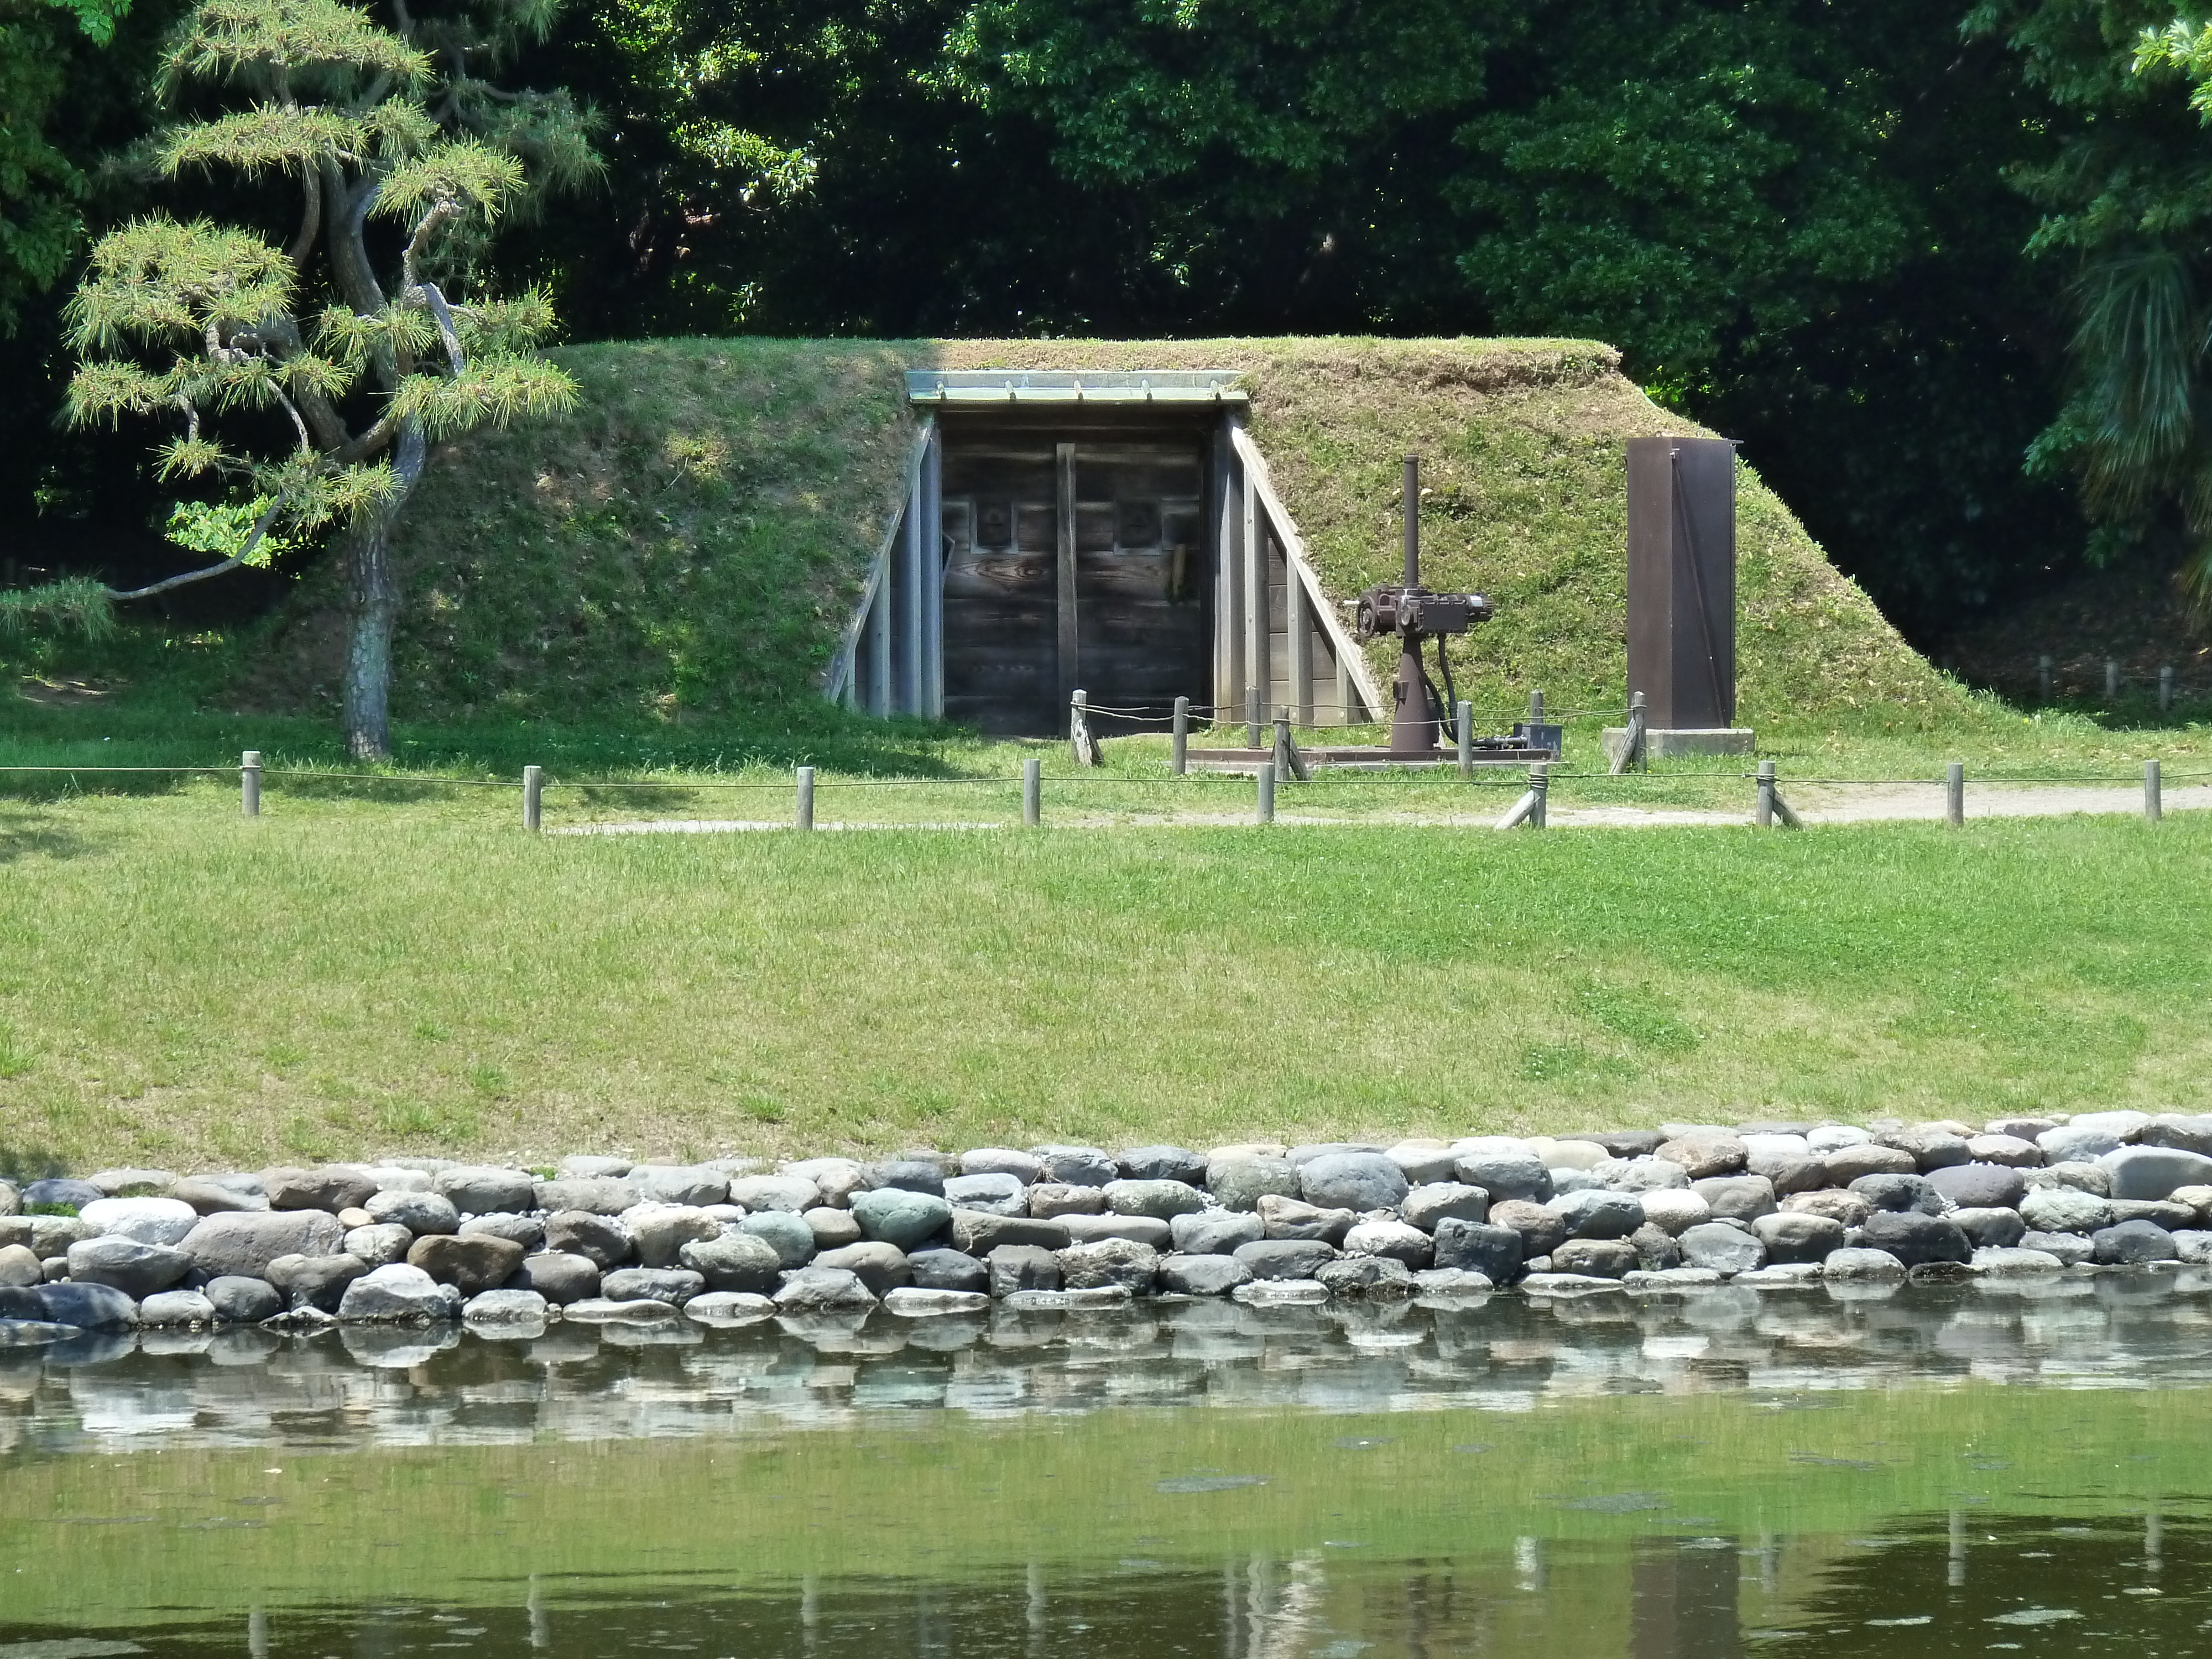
[0,1113,2212,1345]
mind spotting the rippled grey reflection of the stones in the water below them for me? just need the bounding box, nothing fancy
[0,1270,2212,1453]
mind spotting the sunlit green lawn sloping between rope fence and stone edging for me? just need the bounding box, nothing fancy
[0,781,2212,1168]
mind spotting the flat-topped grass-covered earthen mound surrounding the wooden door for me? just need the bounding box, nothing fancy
[263,338,1964,728]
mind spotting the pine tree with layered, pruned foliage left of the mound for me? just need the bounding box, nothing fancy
[58,0,599,759]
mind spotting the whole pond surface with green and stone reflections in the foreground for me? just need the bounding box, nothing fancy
[0,1272,2212,1659]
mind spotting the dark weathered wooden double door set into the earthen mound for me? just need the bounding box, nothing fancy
[942,427,1214,737]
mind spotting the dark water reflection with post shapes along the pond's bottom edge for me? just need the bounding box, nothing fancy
[0,1511,2212,1659]
